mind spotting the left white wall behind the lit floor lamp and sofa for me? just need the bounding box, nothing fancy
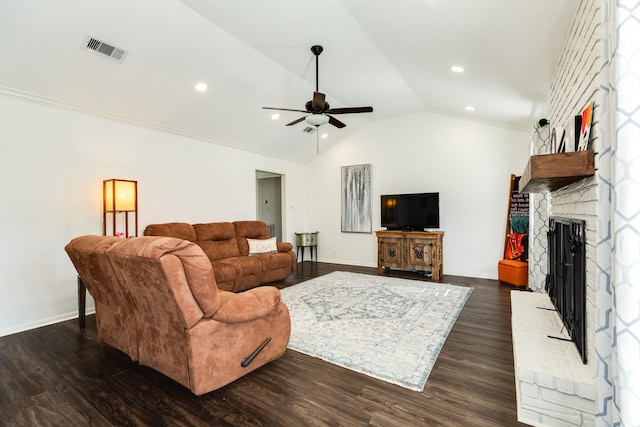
[0,96,305,336]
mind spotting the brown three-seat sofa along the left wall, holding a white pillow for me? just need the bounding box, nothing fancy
[144,221,297,292]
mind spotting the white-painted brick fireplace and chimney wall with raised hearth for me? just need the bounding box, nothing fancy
[512,2,606,427]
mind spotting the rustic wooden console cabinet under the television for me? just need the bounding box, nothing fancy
[376,230,444,281]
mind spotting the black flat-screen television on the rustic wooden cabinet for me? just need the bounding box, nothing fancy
[380,193,440,231]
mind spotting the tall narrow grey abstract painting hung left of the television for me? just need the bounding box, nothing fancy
[341,164,372,233]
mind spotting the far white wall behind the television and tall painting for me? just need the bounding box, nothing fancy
[304,112,533,279]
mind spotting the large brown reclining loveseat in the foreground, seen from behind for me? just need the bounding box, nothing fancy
[65,236,291,395]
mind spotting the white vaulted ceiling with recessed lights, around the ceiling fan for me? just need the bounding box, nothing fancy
[0,0,577,162]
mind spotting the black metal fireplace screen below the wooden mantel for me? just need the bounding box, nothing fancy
[546,217,587,363]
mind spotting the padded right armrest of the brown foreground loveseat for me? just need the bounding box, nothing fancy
[211,286,280,323]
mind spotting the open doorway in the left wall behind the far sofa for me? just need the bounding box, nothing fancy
[256,170,283,242]
